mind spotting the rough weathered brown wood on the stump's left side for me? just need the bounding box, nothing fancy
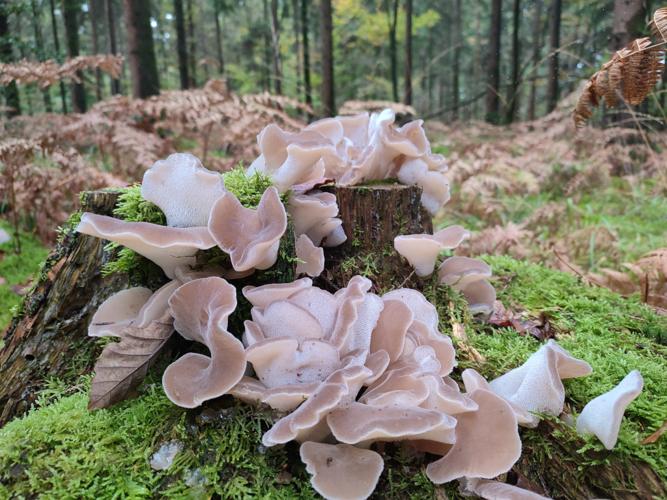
[0,191,127,425]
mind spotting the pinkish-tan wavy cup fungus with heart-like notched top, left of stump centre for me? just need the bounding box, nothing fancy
[208,187,287,271]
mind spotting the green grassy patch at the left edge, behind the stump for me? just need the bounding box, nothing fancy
[0,222,48,332]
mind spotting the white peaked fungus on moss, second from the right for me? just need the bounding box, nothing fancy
[490,340,592,415]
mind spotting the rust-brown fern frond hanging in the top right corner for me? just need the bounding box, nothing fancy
[573,7,667,128]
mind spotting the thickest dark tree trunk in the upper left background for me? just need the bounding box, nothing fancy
[123,0,160,99]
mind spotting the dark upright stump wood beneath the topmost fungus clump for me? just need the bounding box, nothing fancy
[317,184,433,292]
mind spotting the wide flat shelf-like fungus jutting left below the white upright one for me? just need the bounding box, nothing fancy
[76,213,215,278]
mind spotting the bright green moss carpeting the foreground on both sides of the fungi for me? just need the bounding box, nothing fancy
[0,257,667,498]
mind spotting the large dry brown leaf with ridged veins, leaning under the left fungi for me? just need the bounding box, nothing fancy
[88,318,174,410]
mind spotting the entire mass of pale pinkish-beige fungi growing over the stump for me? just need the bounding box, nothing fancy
[78,111,641,499]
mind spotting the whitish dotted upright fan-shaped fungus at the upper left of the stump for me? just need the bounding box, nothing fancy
[141,153,225,227]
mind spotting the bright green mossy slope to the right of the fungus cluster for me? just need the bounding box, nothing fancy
[468,257,667,481]
